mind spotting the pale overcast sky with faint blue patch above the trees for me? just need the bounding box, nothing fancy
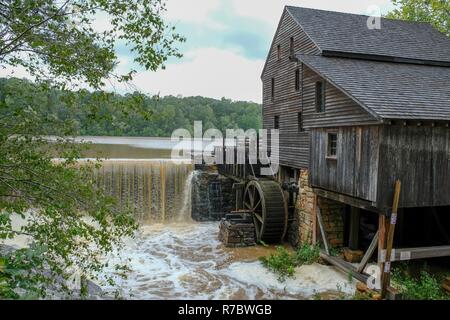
[3,0,391,102]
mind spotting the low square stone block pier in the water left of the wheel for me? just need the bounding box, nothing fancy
[219,215,256,248]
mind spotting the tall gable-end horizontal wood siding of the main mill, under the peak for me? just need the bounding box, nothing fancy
[262,11,319,168]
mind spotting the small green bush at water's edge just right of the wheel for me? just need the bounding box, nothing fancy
[260,245,320,282]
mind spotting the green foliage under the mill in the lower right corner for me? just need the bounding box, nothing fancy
[392,268,450,300]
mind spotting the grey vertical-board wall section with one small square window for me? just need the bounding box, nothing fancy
[310,126,380,202]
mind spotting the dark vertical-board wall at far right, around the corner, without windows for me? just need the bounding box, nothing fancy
[377,125,450,208]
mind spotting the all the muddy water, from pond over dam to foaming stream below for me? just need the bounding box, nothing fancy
[70,137,354,299]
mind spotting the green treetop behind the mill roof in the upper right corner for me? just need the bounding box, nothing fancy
[386,0,450,37]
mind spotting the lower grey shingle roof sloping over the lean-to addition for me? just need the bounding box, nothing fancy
[297,55,450,121]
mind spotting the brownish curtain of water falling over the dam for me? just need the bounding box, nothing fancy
[80,159,194,224]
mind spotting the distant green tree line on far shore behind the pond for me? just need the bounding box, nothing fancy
[0,78,261,137]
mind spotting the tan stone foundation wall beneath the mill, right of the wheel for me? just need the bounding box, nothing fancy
[289,169,345,247]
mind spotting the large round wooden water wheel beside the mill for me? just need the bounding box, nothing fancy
[244,180,288,243]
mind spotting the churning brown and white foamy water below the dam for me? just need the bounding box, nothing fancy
[98,222,354,299]
